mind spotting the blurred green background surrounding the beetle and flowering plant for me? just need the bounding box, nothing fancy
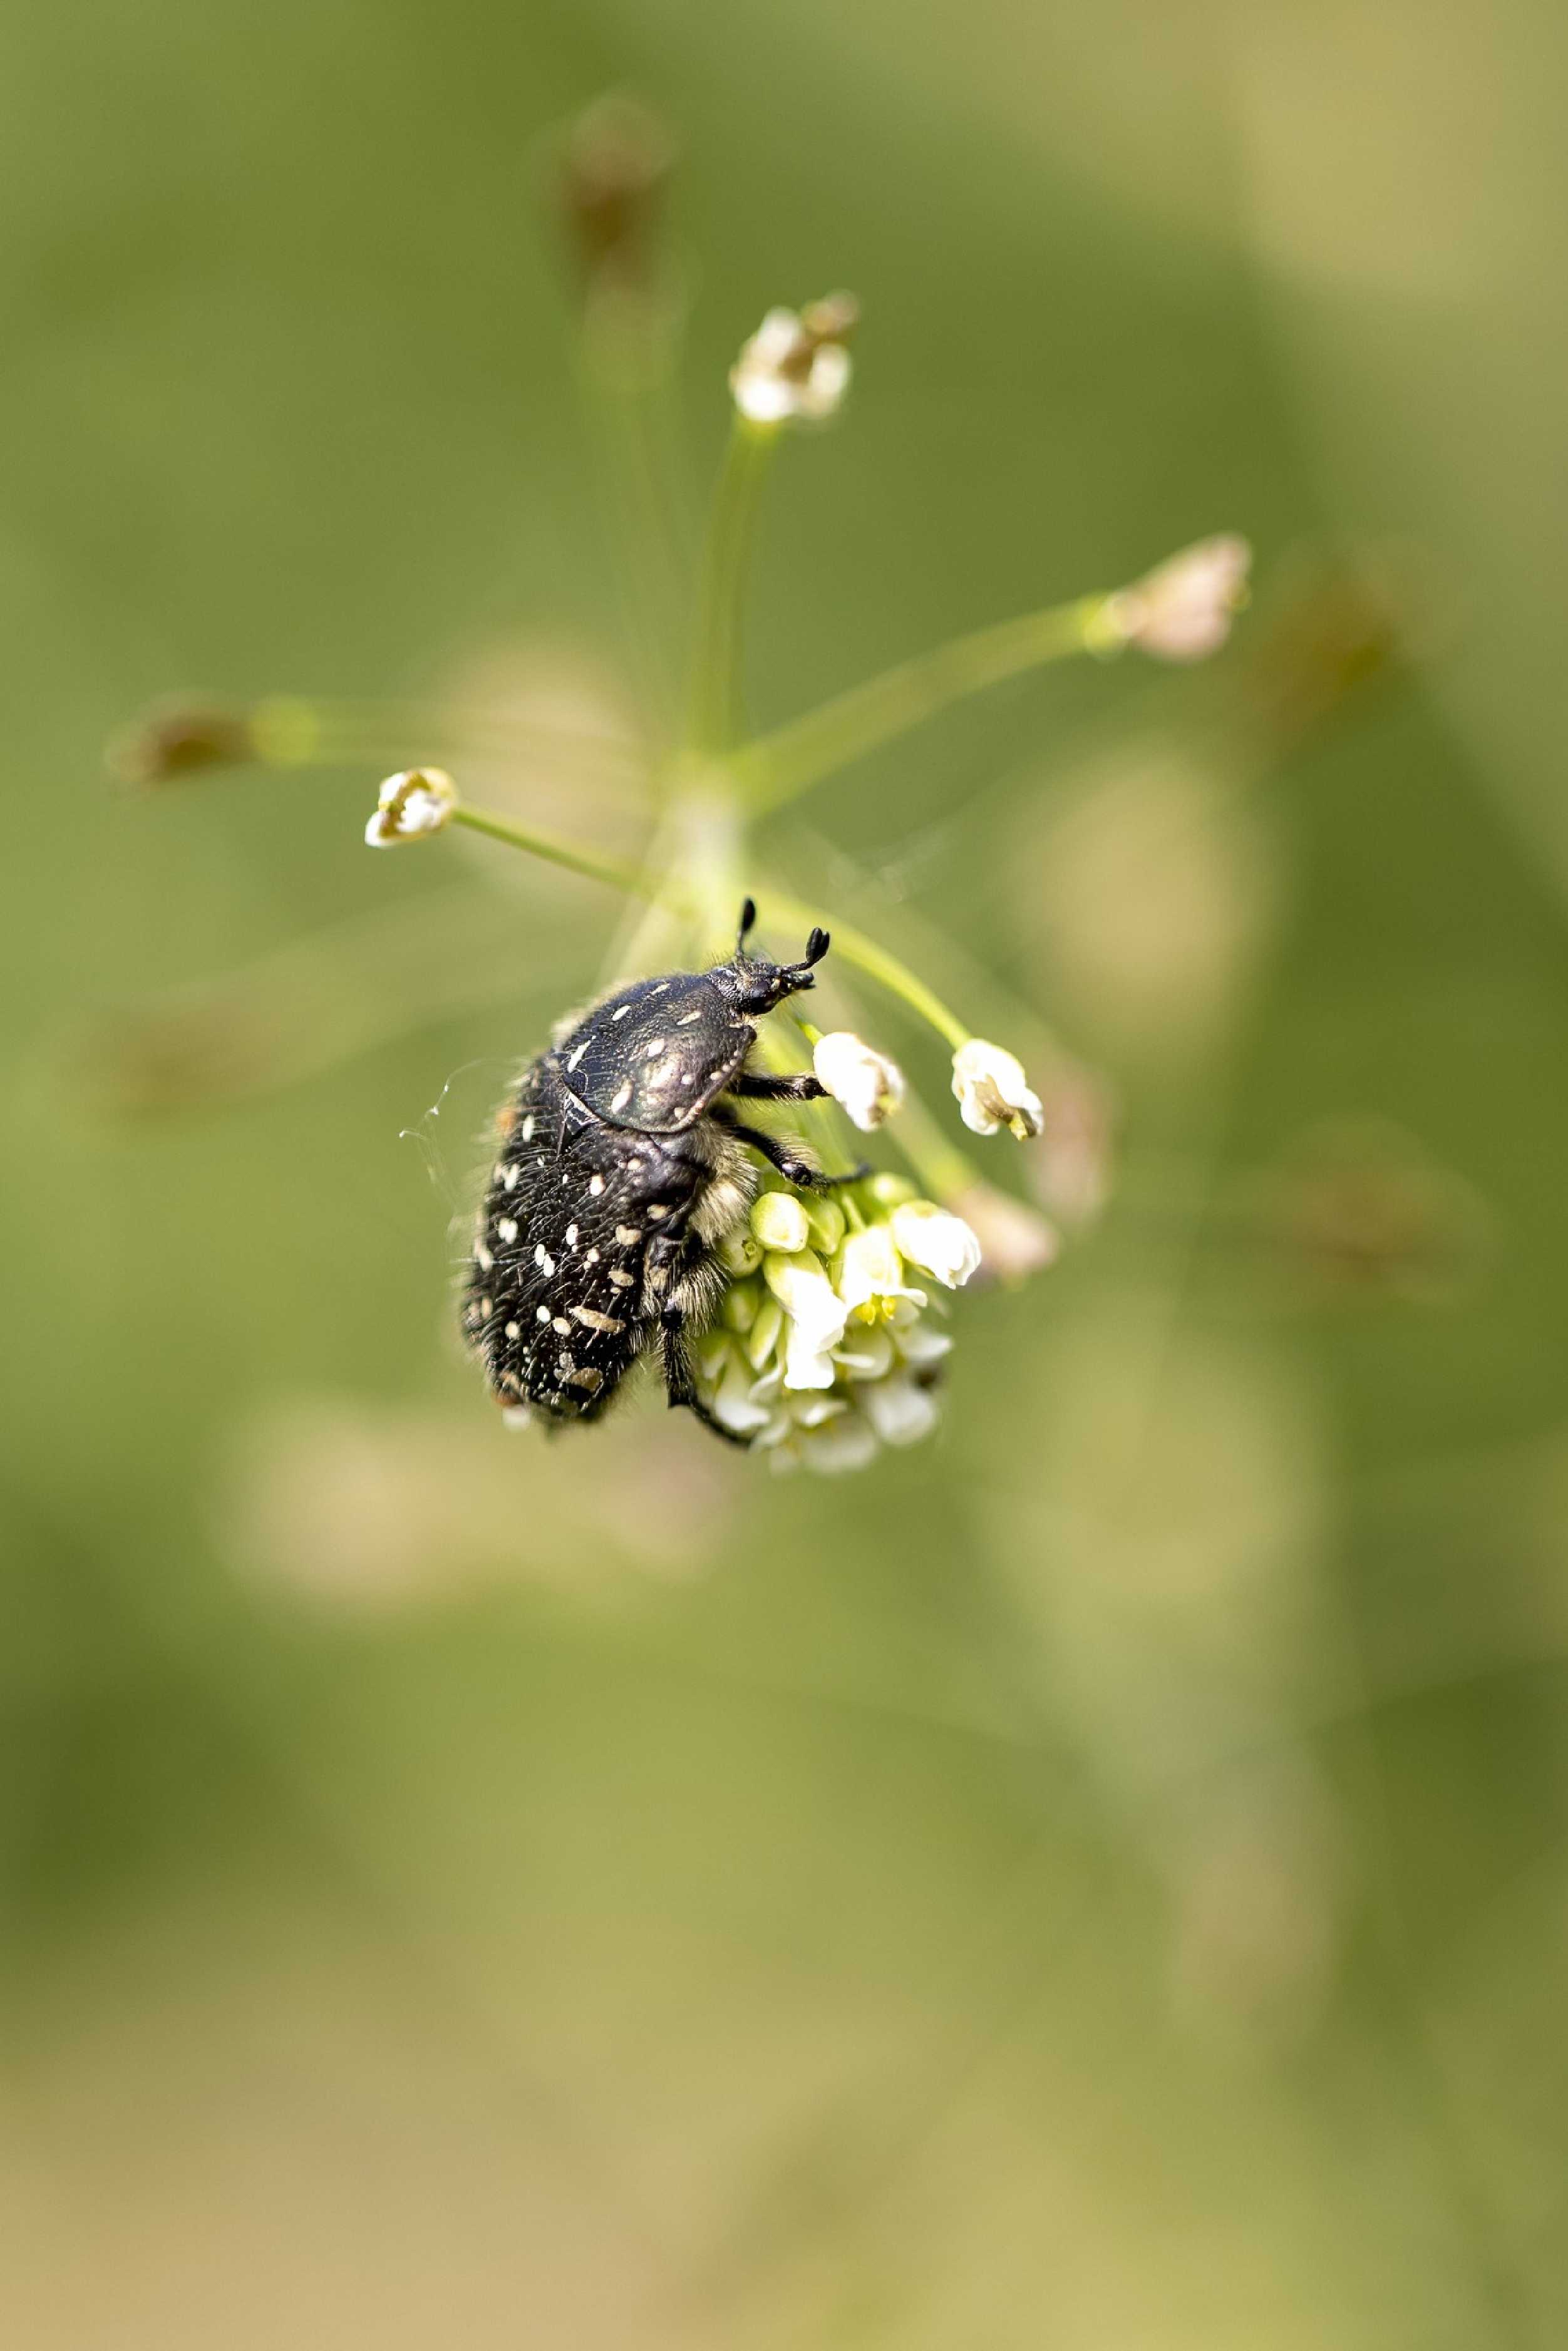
[0,0,1568,2351]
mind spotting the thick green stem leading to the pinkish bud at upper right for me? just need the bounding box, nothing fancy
[731,595,1119,811]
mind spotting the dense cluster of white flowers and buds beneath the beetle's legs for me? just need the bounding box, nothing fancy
[693,1176,980,1472]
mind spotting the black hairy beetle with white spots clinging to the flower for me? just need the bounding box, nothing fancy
[463,898,851,1444]
